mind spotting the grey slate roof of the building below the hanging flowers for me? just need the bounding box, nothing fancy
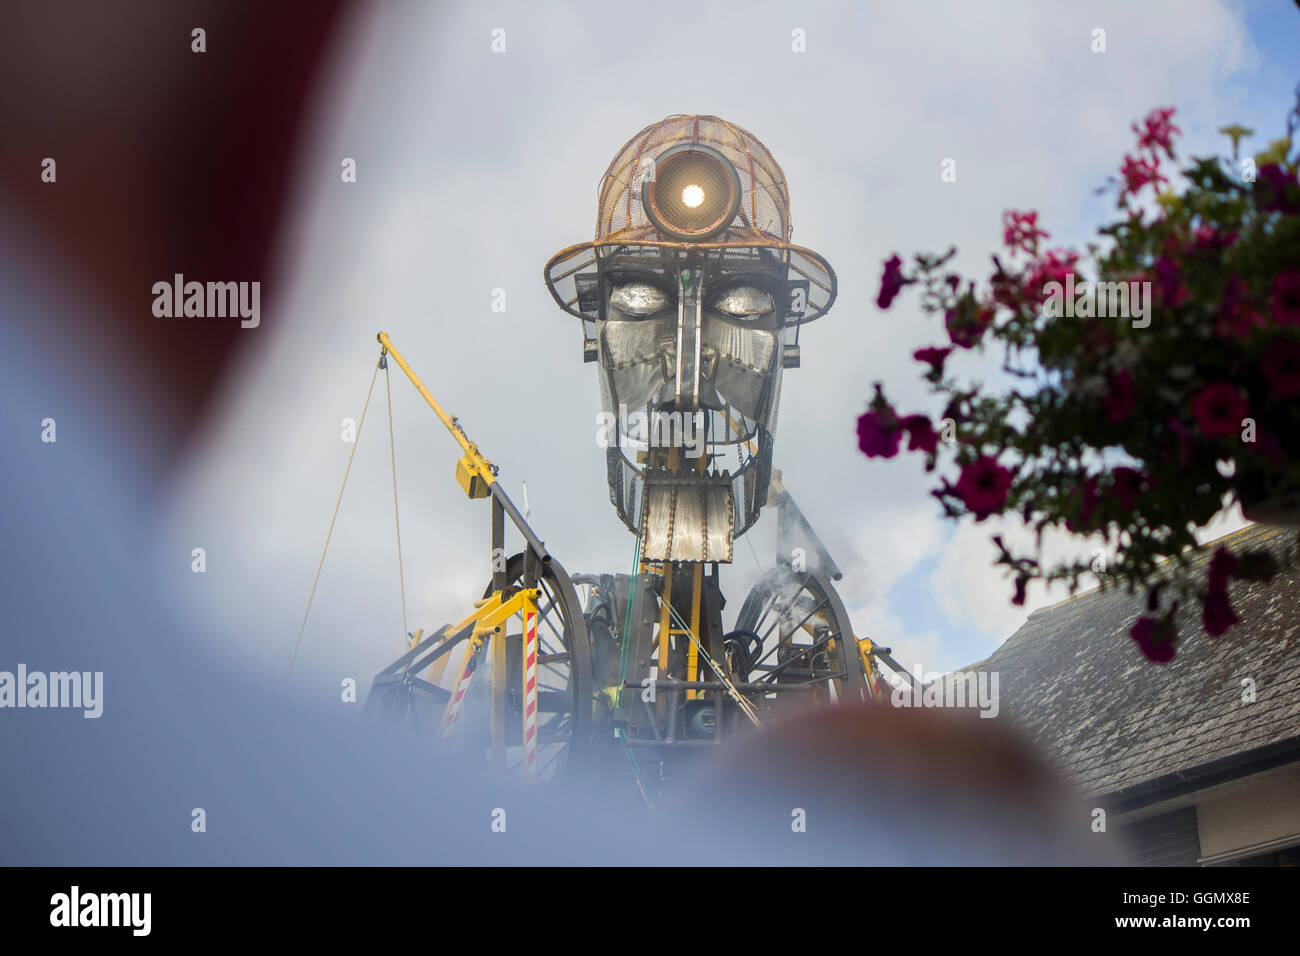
[976,524,1300,806]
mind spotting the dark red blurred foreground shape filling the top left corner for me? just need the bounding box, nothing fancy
[0,0,364,477]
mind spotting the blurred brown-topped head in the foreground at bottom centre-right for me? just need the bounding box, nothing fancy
[662,701,1123,865]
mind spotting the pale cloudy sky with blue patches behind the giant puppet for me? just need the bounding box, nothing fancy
[157,0,1300,696]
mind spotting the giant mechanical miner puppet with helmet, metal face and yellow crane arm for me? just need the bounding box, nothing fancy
[371,116,901,800]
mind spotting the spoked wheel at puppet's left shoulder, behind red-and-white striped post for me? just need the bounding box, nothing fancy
[452,554,592,780]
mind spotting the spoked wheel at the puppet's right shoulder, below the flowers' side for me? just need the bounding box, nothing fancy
[727,567,868,704]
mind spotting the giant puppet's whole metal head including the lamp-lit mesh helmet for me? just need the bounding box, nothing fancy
[546,116,835,562]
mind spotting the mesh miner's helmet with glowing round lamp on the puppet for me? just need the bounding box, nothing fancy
[545,114,836,326]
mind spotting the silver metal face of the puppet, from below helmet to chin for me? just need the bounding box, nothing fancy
[597,251,787,562]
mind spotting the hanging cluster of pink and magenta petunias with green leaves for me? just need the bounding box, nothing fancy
[858,102,1300,662]
